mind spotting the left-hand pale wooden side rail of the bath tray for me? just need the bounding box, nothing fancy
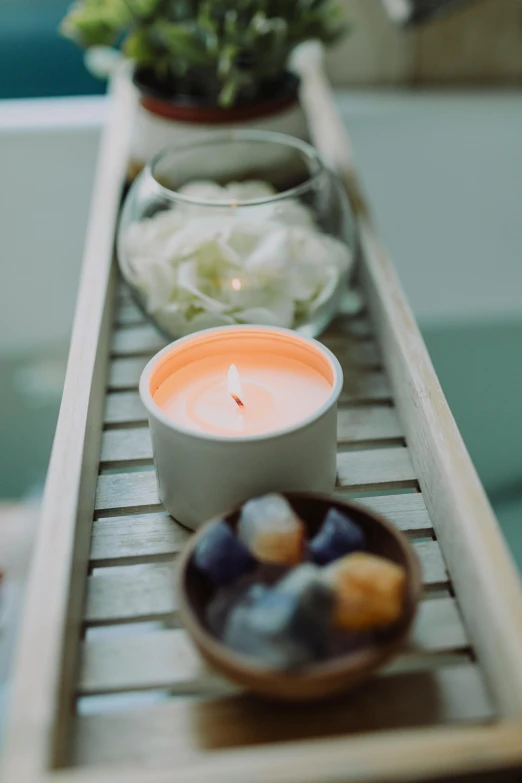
[1,71,135,783]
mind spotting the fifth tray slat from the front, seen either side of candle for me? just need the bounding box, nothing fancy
[96,448,416,512]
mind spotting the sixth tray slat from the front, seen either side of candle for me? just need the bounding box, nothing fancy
[100,410,402,465]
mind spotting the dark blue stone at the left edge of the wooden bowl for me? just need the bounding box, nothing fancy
[193,521,257,586]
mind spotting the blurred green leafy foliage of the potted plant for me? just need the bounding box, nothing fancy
[62,0,347,107]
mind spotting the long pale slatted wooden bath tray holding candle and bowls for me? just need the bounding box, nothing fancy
[3,69,522,783]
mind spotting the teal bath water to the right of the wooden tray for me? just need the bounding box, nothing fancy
[423,319,522,571]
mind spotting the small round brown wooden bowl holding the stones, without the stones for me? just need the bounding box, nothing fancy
[177,492,422,700]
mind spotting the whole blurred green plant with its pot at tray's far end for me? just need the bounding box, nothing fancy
[62,0,345,175]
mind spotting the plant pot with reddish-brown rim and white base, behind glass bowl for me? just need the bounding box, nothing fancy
[129,69,308,178]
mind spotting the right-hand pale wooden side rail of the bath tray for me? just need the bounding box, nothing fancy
[297,44,522,717]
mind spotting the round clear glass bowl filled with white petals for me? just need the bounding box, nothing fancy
[118,130,355,339]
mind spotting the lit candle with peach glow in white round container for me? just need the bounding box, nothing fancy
[140,326,343,529]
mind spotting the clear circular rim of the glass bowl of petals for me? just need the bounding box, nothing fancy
[145,129,325,208]
